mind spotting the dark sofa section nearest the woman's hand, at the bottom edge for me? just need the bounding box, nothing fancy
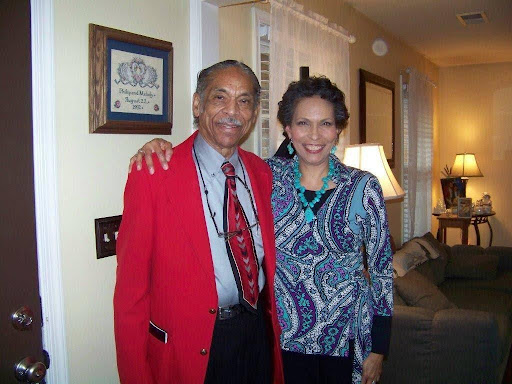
[379,305,434,384]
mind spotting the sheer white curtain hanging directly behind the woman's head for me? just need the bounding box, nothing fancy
[269,0,355,158]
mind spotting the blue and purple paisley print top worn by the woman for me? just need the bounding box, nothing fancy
[267,156,393,382]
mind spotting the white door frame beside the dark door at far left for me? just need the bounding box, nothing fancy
[30,0,69,384]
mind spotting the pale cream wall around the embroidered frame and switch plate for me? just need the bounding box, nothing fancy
[54,0,192,384]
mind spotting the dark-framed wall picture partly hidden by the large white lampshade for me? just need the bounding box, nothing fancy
[359,69,395,168]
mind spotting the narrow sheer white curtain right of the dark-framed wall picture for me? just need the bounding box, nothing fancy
[402,68,435,238]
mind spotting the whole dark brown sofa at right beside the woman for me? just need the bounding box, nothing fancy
[380,233,512,384]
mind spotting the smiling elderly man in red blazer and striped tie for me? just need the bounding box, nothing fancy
[114,60,283,384]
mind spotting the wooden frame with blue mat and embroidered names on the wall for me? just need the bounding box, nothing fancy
[89,24,173,135]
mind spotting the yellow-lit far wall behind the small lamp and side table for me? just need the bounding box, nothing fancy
[436,63,512,246]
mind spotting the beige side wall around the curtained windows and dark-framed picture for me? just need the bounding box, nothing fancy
[219,0,439,243]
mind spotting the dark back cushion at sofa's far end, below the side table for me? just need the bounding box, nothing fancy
[445,245,499,279]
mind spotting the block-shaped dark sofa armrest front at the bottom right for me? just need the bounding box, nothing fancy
[431,309,500,383]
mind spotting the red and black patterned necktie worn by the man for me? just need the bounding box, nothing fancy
[221,161,259,312]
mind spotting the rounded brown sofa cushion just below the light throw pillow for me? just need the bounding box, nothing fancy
[394,270,456,311]
